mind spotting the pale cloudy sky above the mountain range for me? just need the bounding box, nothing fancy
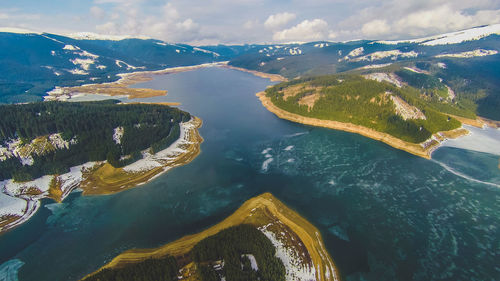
[0,0,500,44]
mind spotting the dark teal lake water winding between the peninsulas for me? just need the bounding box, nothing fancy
[0,68,500,280]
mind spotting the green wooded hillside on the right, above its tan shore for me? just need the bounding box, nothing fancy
[266,75,461,143]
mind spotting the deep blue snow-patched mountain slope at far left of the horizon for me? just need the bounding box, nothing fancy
[0,28,220,102]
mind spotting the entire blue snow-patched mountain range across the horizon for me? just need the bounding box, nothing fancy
[0,24,500,120]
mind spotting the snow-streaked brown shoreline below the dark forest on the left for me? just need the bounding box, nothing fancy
[0,116,203,234]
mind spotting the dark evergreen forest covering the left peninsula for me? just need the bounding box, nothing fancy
[0,100,191,181]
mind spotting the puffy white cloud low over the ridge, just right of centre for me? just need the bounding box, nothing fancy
[273,19,330,42]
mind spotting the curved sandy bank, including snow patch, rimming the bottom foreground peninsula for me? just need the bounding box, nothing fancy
[82,193,340,280]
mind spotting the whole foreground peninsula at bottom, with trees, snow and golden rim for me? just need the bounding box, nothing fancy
[82,193,340,281]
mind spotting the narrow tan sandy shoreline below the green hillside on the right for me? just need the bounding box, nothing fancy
[256,92,469,159]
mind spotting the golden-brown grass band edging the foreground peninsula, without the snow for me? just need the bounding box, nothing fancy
[82,193,338,280]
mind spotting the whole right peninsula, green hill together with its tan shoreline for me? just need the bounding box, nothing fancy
[257,74,484,159]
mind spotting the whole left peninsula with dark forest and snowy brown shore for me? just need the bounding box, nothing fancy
[0,100,203,232]
